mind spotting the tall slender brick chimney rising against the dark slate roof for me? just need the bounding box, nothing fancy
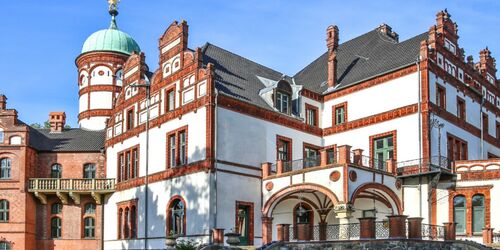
[326,25,339,88]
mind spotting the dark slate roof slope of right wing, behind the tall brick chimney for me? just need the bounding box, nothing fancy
[294,29,427,93]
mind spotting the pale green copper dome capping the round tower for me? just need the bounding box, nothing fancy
[82,16,141,55]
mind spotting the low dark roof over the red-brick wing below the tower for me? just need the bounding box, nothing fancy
[29,127,105,152]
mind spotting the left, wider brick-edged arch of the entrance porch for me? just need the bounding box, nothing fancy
[262,183,339,217]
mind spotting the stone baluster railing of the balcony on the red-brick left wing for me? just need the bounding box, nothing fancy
[28,178,115,192]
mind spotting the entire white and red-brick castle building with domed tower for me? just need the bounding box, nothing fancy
[0,5,500,249]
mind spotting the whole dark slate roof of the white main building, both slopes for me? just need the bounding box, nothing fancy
[202,29,427,110]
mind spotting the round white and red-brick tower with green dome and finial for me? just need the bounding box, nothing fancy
[76,1,140,130]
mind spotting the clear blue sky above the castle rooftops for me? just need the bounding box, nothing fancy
[0,0,500,127]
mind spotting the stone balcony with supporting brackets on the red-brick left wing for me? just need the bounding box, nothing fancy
[28,178,115,204]
